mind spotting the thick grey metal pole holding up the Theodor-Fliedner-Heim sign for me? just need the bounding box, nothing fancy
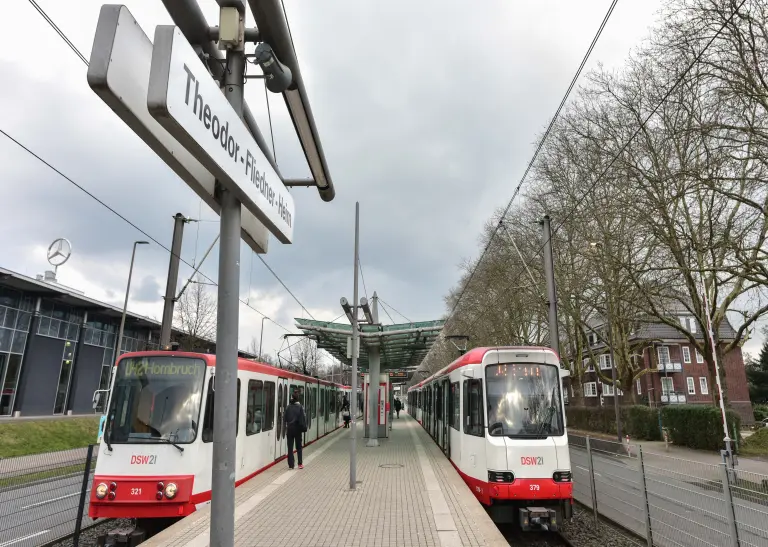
[210,25,245,547]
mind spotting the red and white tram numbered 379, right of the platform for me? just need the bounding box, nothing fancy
[408,347,573,531]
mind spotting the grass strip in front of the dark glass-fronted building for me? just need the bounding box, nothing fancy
[0,416,99,458]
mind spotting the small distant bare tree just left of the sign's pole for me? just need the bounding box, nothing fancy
[174,282,217,350]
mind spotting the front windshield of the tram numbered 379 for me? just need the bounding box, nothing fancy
[485,363,564,438]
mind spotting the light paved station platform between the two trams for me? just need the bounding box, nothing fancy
[144,418,509,547]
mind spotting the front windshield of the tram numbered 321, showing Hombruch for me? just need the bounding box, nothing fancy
[105,356,206,444]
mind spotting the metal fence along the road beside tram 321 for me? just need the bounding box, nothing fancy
[0,445,98,547]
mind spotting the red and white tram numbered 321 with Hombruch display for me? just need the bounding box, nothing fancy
[88,351,359,519]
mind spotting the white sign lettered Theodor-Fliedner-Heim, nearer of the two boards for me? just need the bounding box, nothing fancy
[147,25,295,243]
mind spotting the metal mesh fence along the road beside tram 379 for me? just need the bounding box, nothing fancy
[569,435,768,547]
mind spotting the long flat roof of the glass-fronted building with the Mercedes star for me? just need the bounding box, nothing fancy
[0,268,256,358]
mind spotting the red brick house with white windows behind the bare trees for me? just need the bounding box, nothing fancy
[566,314,754,424]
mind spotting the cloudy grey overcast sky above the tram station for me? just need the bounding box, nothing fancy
[0,0,760,366]
